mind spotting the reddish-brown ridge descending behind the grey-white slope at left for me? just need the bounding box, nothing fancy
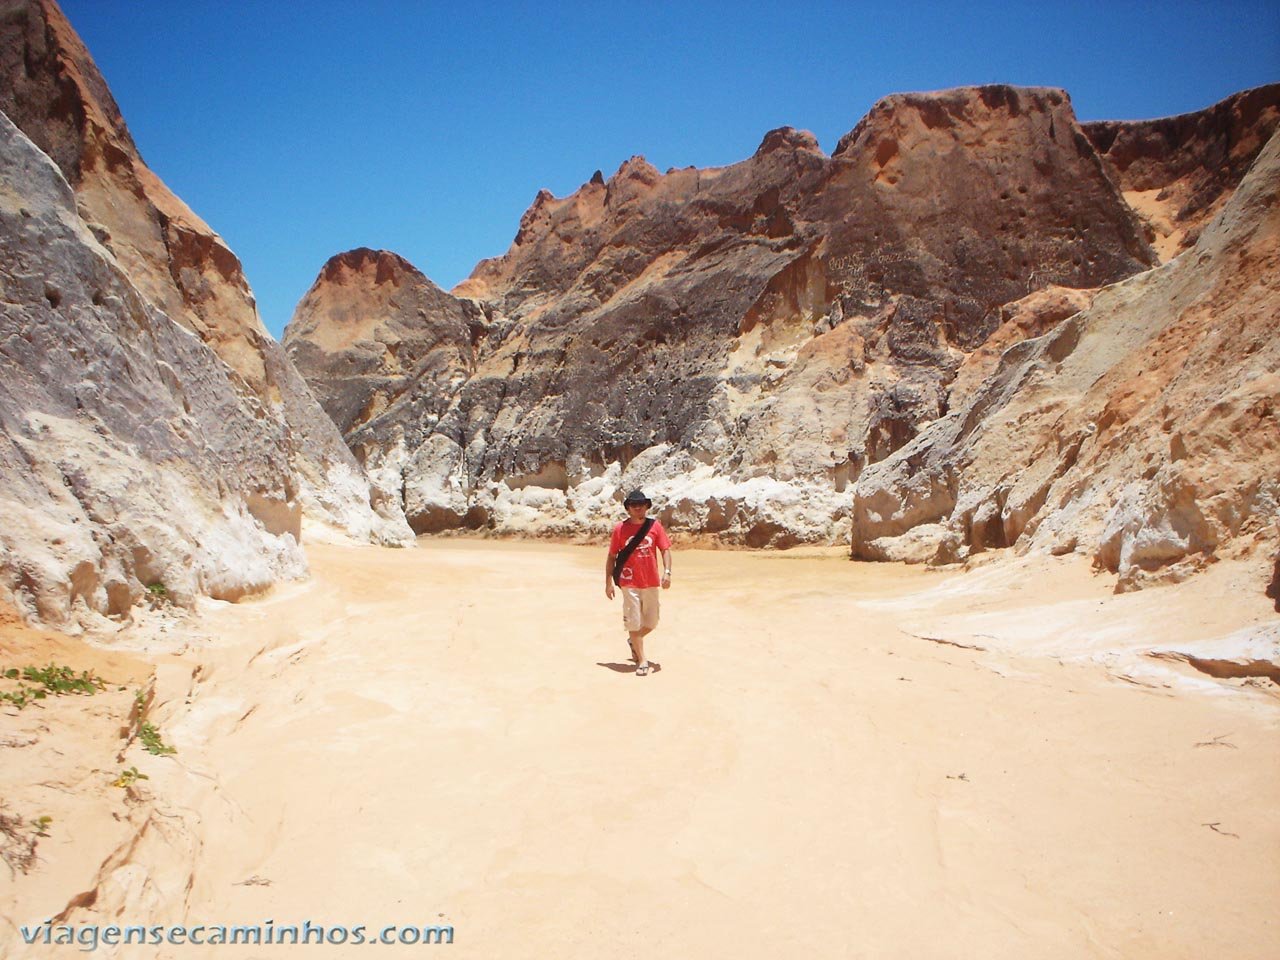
[0,0,408,541]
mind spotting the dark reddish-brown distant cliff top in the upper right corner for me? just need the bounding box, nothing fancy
[1084,83,1280,260]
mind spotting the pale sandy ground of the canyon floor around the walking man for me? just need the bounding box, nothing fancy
[0,540,1280,960]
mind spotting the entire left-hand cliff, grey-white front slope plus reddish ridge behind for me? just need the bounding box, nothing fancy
[0,3,410,623]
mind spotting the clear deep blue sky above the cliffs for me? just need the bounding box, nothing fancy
[63,0,1280,337]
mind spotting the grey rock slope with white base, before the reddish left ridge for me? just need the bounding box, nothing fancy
[0,115,306,622]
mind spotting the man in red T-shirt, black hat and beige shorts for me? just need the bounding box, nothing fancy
[604,490,671,677]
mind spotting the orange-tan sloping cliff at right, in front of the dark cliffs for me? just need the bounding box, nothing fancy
[852,136,1280,590]
